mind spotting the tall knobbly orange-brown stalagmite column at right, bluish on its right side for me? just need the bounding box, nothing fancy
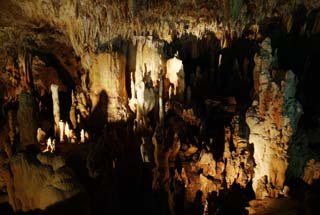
[246,38,302,198]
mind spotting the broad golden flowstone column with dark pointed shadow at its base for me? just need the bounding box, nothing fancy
[89,52,128,122]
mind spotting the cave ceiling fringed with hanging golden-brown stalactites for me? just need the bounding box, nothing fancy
[0,0,319,64]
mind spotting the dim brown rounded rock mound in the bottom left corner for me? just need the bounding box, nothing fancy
[1,153,83,211]
